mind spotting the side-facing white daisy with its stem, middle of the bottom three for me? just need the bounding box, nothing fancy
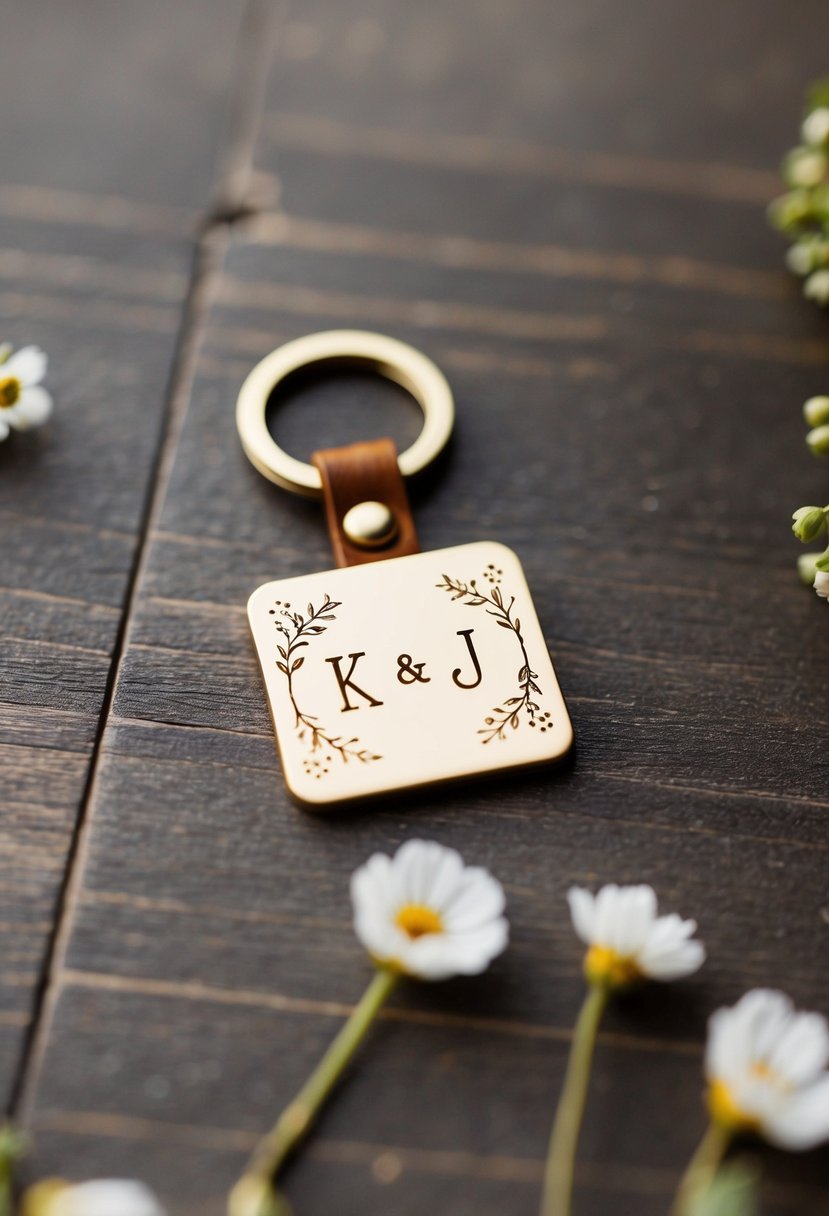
[541,883,705,1216]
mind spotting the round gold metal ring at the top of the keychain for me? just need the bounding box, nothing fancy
[236,330,455,497]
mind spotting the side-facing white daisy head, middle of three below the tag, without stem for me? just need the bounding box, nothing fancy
[568,883,705,987]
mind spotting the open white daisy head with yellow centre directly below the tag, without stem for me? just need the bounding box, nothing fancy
[351,840,508,980]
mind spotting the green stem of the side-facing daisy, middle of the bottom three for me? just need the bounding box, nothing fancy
[541,984,610,1216]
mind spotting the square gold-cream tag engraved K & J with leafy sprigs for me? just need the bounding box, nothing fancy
[248,541,573,807]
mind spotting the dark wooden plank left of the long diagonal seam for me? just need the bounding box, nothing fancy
[0,2,249,1104]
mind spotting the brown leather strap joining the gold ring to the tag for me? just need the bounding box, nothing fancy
[311,439,421,567]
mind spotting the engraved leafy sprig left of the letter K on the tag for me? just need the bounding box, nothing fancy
[270,593,383,781]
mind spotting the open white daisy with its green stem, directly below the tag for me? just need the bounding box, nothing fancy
[227,840,508,1216]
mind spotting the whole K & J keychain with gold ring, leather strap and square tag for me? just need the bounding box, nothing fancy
[236,330,573,809]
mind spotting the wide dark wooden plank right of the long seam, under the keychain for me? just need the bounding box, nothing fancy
[9,0,829,1216]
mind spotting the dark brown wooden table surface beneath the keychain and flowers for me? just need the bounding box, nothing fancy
[0,0,829,1216]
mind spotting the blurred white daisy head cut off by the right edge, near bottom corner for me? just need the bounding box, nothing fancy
[705,989,829,1150]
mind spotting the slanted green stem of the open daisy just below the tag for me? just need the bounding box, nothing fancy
[235,967,399,1206]
